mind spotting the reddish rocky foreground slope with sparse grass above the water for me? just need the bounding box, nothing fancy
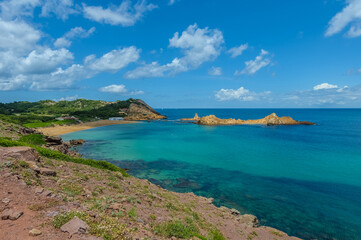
[0,122,298,240]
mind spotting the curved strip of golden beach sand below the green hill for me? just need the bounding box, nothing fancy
[36,120,136,136]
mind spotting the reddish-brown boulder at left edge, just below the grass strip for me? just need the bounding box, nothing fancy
[0,147,40,162]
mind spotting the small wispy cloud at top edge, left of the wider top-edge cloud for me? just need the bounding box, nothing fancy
[41,0,79,20]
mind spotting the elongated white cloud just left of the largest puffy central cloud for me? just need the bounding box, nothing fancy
[85,46,140,72]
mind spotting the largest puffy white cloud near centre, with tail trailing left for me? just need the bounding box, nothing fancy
[125,24,224,78]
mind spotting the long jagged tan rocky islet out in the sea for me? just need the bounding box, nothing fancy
[181,113,314,126]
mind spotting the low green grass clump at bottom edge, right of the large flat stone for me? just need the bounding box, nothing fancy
[154,220,199,239]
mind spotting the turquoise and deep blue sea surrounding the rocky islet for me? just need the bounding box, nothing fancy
[63,109,361,239]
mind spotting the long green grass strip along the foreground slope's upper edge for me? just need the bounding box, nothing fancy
[0,138,129,177]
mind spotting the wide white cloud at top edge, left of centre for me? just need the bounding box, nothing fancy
[83,0,157,27]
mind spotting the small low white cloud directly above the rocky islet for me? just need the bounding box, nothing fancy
[215,87,271,102]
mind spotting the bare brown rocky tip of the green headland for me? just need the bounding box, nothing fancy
[124,99,167,121]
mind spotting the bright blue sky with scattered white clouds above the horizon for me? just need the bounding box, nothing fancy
[0,0,361,108]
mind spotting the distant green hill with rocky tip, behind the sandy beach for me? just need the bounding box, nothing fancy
[0,98,165,127]
